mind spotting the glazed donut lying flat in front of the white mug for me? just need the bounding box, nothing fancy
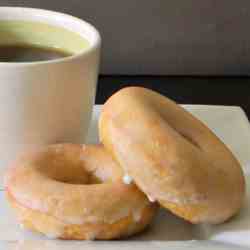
[5,144,156,240]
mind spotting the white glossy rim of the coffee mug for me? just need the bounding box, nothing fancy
[0,6,101,67]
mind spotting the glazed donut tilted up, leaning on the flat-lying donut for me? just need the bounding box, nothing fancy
[99,87,245,224]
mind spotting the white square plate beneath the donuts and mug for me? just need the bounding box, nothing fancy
[0,105,250,250]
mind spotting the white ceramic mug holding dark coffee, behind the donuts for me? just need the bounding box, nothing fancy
[0,7,101,182]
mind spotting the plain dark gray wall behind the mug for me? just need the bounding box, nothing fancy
[0,0,250,75]
